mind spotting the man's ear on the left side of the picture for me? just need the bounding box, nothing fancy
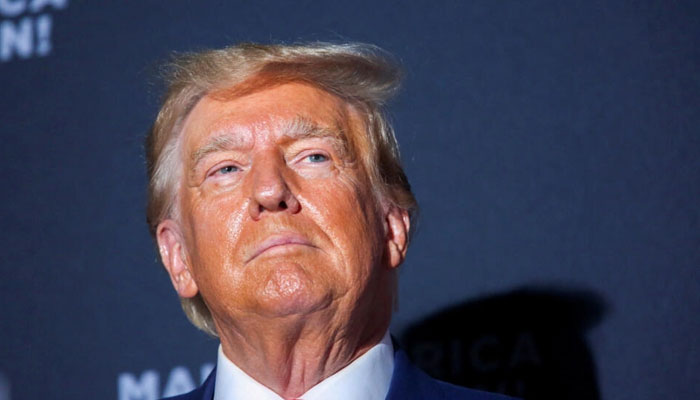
[156,219,199,297]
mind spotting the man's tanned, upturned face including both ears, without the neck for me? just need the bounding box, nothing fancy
[158,83,408,332]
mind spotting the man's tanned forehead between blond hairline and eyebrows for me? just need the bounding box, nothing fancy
[182,83,351,151]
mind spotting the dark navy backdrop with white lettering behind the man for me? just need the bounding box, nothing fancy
[0,0,700,400]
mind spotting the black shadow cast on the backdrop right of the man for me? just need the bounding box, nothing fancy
[400,287,607,400]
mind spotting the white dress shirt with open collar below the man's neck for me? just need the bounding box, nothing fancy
[214,331,394,400]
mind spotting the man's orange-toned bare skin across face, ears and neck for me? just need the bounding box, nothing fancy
[157,83,409,398]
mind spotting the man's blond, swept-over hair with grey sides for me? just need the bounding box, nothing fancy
[146,43,417,336]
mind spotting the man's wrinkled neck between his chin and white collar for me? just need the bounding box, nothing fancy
[218,308,389,399]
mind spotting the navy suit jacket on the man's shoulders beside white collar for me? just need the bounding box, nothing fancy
[164,349,510,400]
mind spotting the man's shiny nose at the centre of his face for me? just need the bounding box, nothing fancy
[248,156,301,220]
